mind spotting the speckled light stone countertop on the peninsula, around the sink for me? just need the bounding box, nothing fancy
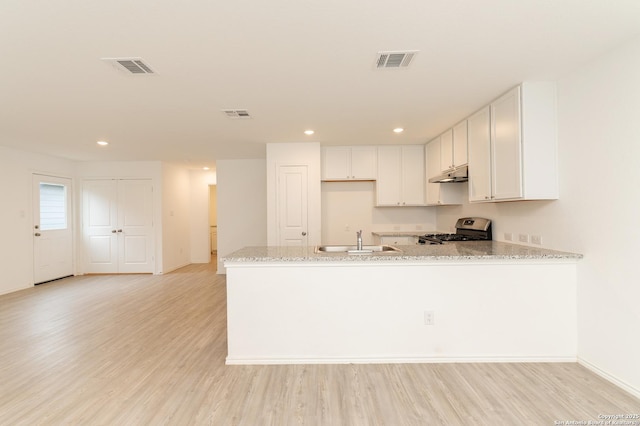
[222,241,582,266]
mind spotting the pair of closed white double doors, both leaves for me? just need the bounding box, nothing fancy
[82,179,154,273]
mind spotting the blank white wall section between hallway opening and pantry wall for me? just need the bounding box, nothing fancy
[216,159,267,274]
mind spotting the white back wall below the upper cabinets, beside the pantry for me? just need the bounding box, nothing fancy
[322,181,436,244]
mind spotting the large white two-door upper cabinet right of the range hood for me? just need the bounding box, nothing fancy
[468,82,558,201]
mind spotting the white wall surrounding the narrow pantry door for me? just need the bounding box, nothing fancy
[266,142,322,245]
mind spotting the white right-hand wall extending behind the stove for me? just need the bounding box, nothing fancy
[437,34,640,395]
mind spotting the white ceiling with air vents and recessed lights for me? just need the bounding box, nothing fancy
[0,0,640,166]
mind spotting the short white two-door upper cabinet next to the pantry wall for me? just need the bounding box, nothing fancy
[322,146,377,180]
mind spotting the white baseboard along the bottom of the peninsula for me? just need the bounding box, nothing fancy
[225,356,576,365]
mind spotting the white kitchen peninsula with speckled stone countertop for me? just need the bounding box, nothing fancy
[224,241,582,364]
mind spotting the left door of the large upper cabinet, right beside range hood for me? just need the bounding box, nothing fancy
[467,106,491,201]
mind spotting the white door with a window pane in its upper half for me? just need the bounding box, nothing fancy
[33,174,73,284]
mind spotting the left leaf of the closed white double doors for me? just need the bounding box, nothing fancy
[82,179,118,274]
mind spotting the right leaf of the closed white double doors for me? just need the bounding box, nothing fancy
[117,179,153,273]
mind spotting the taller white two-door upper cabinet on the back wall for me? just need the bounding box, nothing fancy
[376,145,425,206]
